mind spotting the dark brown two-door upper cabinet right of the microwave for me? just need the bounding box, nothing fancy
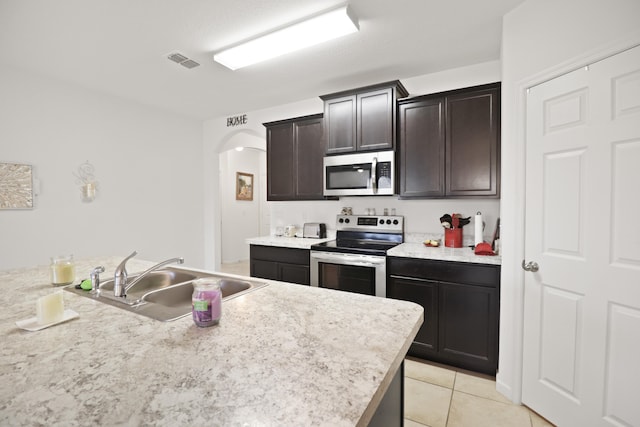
[398,83,500,198]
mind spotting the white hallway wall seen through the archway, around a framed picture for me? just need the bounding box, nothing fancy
[220,149,266,262]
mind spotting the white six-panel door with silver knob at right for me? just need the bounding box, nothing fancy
[522,47,640,426]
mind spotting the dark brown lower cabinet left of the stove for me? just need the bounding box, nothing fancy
[249,245,310,285]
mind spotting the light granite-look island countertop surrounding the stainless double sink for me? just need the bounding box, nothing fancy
[0,257,423,426]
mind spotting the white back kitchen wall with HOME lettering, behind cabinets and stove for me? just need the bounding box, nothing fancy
[204,61,501,268]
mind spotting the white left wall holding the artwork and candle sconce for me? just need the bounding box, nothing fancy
[0,66,203,273]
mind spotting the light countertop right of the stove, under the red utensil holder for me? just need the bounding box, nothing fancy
[387,243,502,265]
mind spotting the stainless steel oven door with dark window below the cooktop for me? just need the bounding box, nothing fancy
[310,251,387,298]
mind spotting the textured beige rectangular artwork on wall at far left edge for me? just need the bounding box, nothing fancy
[0,163,33,210]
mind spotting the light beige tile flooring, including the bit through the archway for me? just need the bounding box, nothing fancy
[220,261,552,427]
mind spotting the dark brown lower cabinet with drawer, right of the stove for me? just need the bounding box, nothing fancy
[387,257,500,375]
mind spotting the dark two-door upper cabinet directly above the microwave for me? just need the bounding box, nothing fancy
[320,80,408,154]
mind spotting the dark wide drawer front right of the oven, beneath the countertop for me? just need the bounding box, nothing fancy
[387,257,500,288]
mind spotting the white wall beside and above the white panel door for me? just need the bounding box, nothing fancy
[497,0,640,402]
